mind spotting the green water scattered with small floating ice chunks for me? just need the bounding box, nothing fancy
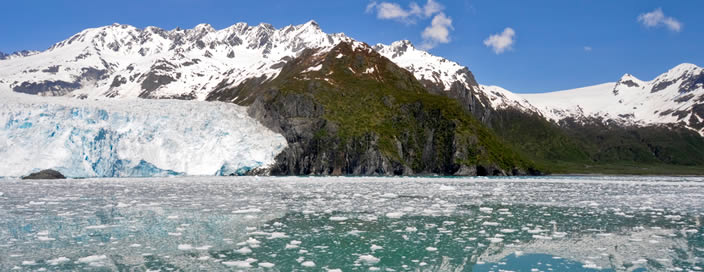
[0,177,704,271]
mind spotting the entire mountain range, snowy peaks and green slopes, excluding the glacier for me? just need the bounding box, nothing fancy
[0,21,704,175]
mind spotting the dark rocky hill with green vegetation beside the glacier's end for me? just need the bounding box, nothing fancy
[209,43,539,175]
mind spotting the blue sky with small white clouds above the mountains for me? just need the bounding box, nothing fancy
[0,0,704,93]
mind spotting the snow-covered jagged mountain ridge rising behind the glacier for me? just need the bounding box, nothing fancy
[0,21,352,100]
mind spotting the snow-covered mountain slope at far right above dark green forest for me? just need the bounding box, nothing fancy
[522,63,704,134]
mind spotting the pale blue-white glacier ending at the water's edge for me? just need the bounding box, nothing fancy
[0,92,287,177]
